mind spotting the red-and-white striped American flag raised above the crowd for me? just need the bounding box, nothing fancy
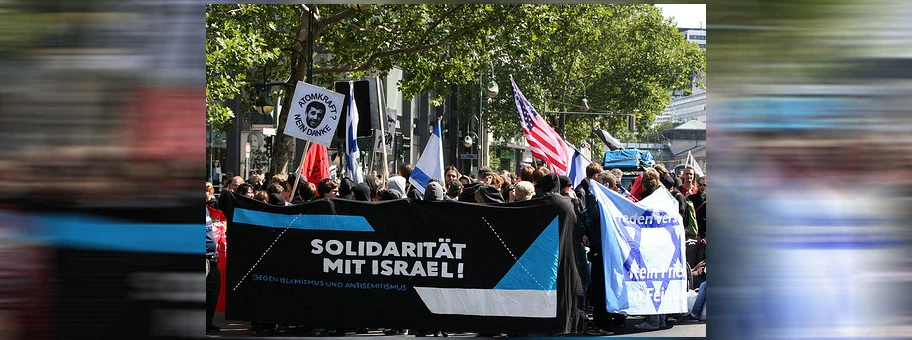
[510,76,569,175]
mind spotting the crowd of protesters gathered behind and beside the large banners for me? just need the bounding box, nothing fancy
[206,163,706,336]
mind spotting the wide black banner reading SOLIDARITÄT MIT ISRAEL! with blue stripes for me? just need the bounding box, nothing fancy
[224,194,582,333]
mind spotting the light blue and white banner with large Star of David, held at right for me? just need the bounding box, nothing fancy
[589,181,687,315]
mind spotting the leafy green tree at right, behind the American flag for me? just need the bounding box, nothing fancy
[469,5,705,158]
